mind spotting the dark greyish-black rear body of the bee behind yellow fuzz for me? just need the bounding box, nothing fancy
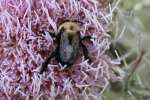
[58,34,79,65]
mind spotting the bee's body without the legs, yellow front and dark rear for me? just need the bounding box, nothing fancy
[57,23,80,65]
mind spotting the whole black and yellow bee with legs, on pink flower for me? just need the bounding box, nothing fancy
[40,21,91,74]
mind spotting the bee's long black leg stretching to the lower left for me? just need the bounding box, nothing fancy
[40,51,56,74]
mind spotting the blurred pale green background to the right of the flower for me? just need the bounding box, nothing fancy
[103,0,150,100]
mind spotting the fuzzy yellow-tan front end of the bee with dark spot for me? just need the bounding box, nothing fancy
[58,22,80,35]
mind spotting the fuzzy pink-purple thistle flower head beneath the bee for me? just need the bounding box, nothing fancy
[0,0,116,100]
